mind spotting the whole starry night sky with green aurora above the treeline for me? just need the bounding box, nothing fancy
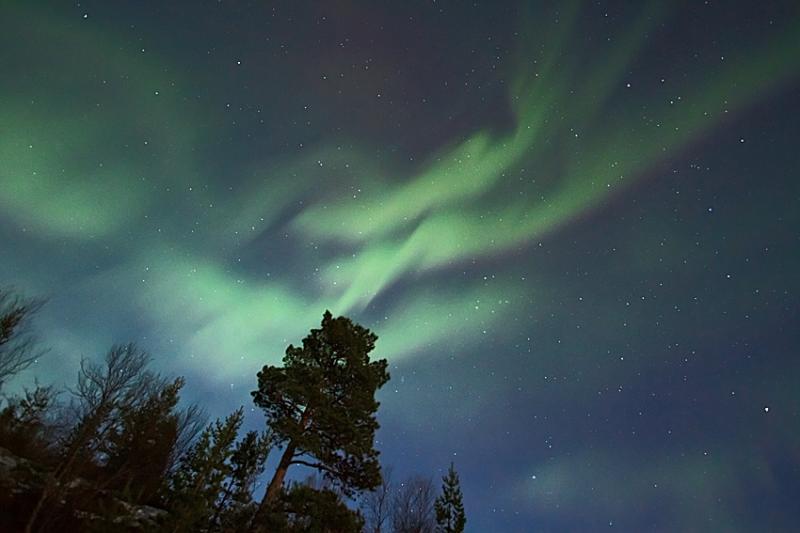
[0,0,800,532]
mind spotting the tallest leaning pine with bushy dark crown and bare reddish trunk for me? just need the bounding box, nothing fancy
[252,311,389,528]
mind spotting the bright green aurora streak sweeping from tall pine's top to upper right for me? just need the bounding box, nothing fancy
[296,3,800,310]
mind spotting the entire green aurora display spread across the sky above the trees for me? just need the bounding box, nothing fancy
[0,3,800,380]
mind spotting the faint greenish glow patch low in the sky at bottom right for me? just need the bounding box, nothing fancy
[515,449,772,531]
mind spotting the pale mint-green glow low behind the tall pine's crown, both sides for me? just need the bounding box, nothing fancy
[95,245,522,380]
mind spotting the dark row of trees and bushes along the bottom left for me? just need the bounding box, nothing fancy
[0,289,466,533]
